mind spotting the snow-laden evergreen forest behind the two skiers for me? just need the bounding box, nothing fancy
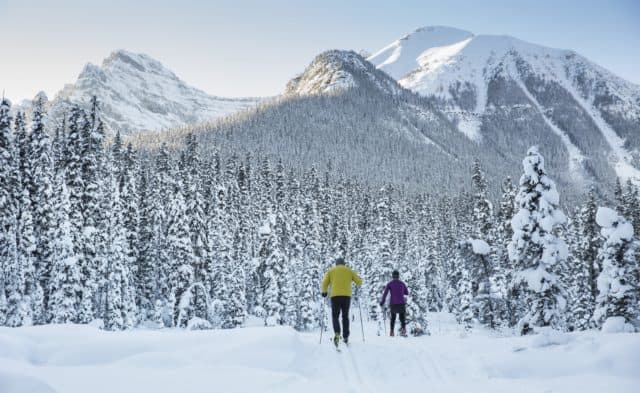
[0,99,640,334]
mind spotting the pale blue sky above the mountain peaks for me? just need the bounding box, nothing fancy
[0,0,640,100]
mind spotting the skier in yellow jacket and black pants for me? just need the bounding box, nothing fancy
[321,258,362,345]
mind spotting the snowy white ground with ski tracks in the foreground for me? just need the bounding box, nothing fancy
[0,315,640,393]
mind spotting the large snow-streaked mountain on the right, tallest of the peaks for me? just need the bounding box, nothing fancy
[368,27,640,181]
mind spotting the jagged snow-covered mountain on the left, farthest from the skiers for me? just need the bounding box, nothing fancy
[45,50,258,134]
